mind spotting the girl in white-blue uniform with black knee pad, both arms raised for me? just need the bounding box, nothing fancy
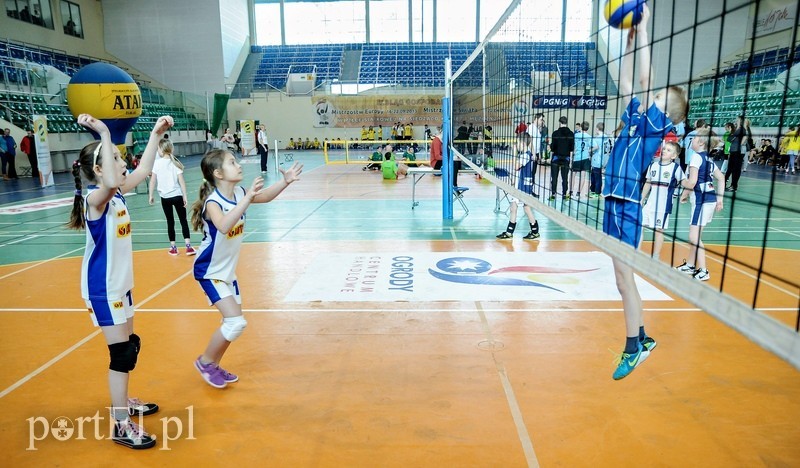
[67,114,173,449]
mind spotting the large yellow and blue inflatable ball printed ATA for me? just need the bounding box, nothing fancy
[67,62,142,145]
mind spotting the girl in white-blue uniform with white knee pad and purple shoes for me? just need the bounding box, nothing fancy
[192,150,303,388]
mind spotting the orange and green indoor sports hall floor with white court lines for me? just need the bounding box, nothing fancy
[0,153,800,467]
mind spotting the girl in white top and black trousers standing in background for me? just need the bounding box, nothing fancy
[149,140,196,255]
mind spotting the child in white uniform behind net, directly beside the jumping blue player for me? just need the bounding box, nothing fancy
[642,141,685,258]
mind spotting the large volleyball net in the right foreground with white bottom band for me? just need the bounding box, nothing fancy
[444,0,800,368]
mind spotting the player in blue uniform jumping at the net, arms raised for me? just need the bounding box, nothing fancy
[603,5,687,380]
